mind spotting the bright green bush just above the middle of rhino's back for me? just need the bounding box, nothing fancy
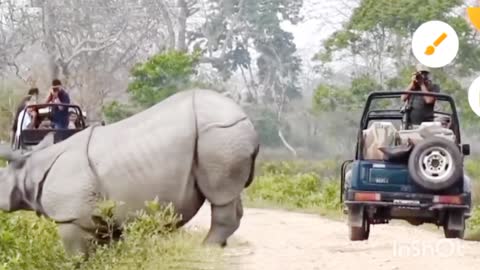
[128,51,199,108]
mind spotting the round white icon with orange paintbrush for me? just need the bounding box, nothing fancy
[412,21,459,68]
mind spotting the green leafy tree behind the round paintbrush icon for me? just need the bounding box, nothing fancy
[316,0,472,83]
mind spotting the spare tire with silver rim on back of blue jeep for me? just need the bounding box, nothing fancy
[408,137,463,191]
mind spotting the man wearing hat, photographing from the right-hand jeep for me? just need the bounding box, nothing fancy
[401,64,440,125]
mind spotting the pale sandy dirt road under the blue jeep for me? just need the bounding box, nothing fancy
[187,205,480,270]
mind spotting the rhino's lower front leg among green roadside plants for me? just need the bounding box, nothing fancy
[58,223,92,256]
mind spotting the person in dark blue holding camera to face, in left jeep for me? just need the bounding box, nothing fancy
[47,79,70,129]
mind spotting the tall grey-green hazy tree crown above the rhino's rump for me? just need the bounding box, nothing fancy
[196,0,303,102]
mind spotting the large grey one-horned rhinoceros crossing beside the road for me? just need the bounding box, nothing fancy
[0,89,259,254]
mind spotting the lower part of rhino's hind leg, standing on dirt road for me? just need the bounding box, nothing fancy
[204,197,243,247]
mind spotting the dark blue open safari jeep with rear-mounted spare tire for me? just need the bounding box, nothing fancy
[341,92,471,241]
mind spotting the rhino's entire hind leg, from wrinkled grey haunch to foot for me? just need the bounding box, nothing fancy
[194,121,258,246]
